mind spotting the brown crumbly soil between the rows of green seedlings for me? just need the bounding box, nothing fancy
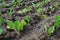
[0,0,60,40]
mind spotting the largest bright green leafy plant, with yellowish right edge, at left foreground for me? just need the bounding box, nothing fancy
[6,20,27,34]
